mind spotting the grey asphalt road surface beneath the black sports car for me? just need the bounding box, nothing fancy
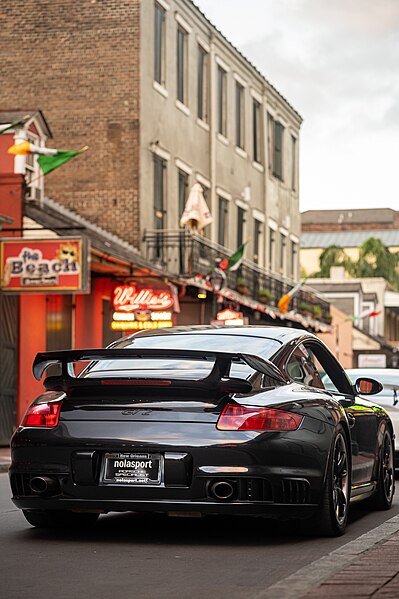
[0,474,399,599]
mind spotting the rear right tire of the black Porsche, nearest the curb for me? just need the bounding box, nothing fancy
[302,425,351,537]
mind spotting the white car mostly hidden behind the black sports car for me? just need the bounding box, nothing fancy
[323,368,399,471]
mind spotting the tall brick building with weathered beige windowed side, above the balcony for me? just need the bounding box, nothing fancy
[0,0,301,279]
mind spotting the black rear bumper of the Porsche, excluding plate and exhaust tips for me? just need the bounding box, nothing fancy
[10,419,331,518]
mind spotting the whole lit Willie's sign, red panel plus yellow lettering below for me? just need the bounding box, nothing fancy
[111,284,174,331]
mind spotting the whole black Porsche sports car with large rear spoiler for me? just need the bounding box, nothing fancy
[10,326,395,535]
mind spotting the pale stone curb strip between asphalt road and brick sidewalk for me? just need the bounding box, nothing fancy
[252,515,399,599]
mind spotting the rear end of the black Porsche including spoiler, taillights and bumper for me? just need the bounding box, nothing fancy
[10,350,333,518]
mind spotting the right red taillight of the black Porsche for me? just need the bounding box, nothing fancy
[216,404,303,431]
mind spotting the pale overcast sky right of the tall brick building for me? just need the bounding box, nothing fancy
[194,0,399,211]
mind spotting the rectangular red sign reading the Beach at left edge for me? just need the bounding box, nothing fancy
[0,237,88,293]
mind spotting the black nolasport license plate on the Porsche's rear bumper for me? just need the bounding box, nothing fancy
[103,453,162,485]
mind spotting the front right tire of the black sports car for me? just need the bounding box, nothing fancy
[368,429,395,510]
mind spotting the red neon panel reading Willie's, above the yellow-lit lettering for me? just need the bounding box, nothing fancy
[113,285,173,312]
